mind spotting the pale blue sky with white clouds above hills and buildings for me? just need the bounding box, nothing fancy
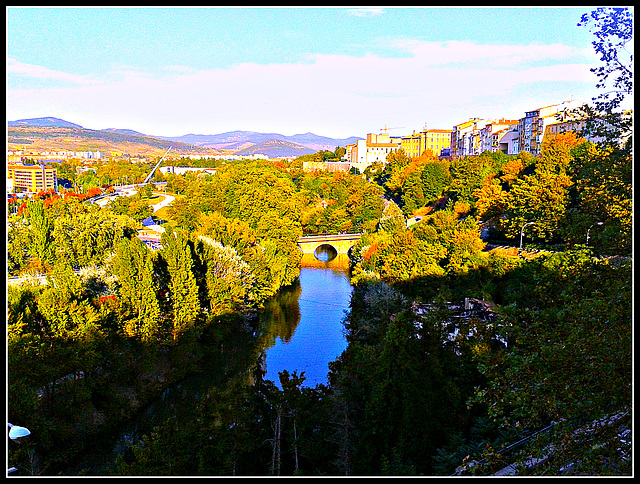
[6,7,616,138]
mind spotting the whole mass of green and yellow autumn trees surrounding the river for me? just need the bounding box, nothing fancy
[7,9,633,476]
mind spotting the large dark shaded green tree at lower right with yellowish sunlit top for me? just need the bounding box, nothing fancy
[476,249,631,428]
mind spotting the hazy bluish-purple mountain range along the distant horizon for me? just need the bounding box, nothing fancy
[8,117,362,158]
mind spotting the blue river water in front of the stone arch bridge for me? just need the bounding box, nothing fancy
[261,254,352,387]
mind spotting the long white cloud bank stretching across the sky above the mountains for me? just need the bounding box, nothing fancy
[7,41,595,136]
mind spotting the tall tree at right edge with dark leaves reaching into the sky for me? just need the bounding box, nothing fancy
[565,8,633,254]
